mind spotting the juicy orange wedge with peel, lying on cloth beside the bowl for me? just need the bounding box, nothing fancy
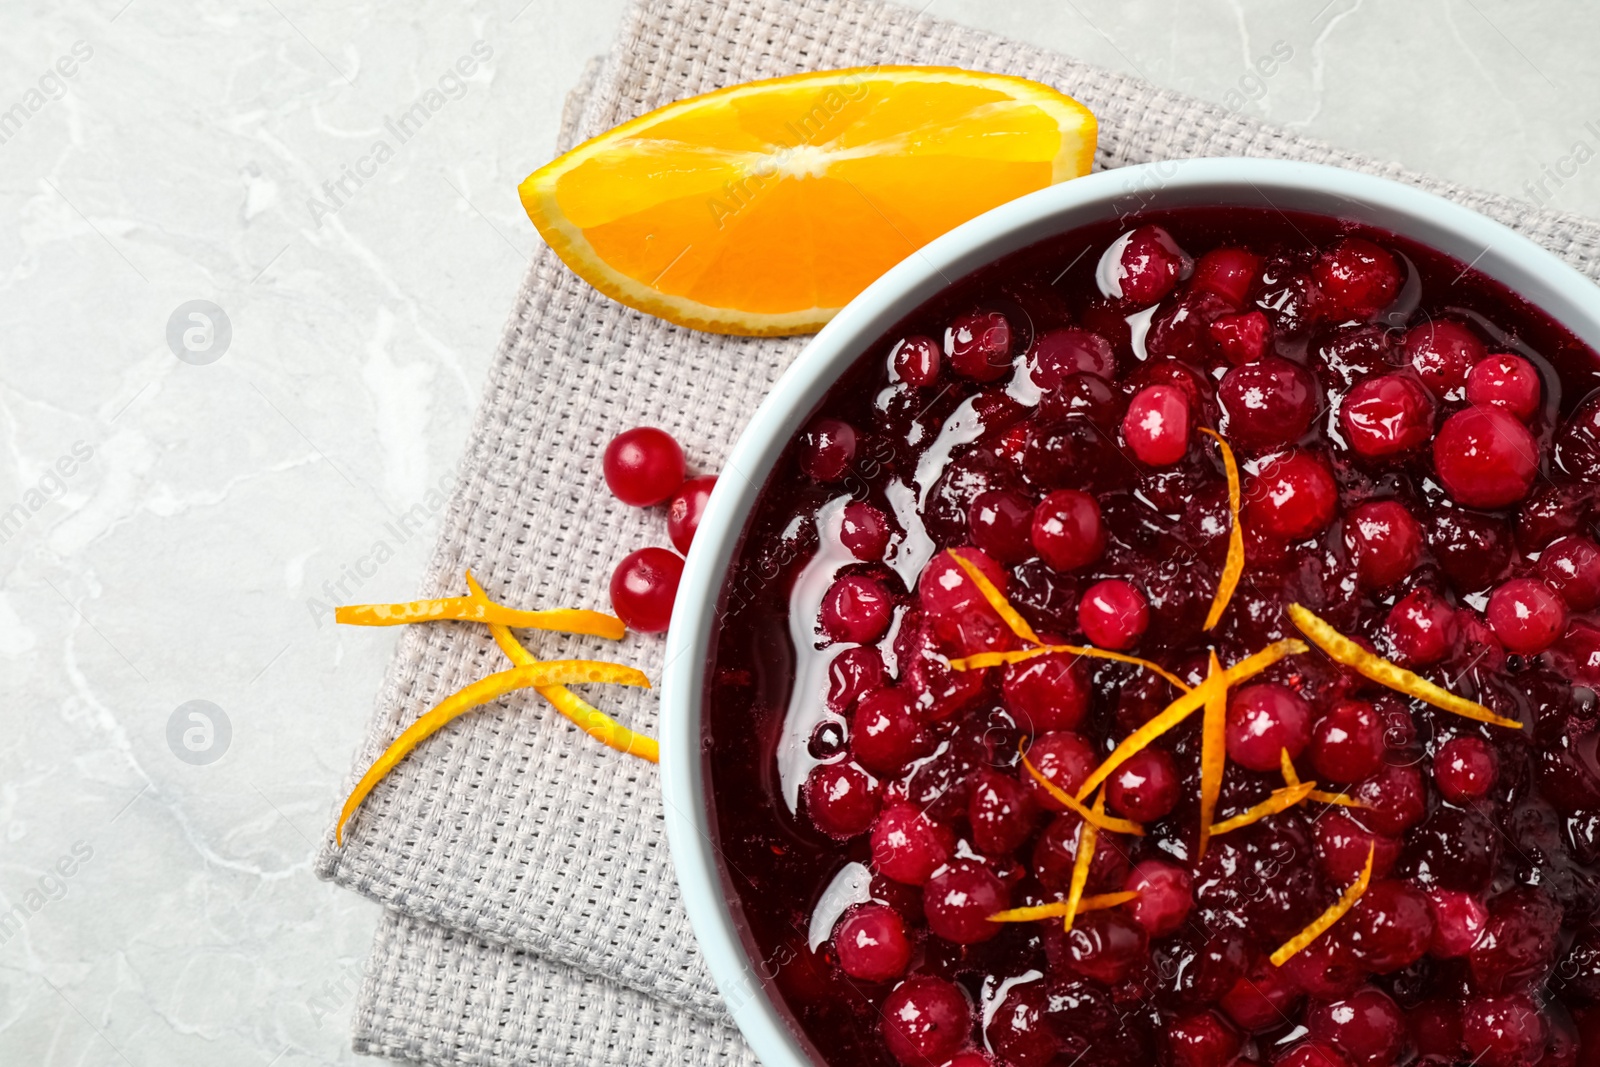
[520,66,1096,336]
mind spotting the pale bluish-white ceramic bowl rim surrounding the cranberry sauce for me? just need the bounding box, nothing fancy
[661,158,1600,1067]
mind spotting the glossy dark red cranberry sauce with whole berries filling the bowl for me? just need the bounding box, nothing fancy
[704,210,1600,1067]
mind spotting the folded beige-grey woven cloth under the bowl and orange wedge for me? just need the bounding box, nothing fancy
[318,0,1600,1067]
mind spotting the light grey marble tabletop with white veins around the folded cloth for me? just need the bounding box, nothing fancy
[0,0,1600,1067]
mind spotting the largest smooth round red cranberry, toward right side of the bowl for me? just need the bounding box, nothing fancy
[1434,405,1539,507]
